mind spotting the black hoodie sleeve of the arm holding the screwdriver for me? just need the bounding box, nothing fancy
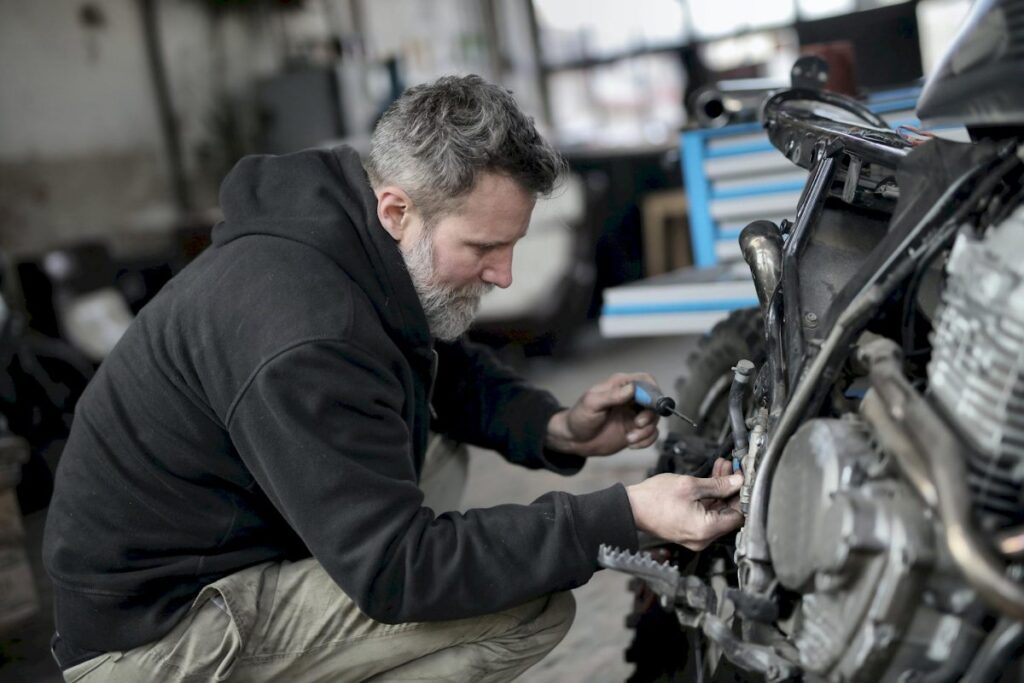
[431,339,586,474]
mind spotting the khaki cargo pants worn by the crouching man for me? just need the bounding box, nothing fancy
[63,441,575,683]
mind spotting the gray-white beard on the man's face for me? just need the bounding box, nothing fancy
[401,229,494,341]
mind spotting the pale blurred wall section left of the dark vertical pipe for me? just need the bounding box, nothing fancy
[0,0,173,251]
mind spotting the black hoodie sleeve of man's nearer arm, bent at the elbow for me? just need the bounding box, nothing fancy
[228,342,637,623]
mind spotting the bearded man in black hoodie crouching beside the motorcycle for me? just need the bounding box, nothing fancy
[44,77,741,681]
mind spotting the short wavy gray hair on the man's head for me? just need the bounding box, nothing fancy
[365,76,566,225]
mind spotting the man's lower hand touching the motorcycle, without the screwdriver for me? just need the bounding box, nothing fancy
[626,464,743,550]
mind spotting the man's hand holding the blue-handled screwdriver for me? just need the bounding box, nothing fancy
[545,373,658,456]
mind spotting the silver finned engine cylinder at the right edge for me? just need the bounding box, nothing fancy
[929,207,1024,527]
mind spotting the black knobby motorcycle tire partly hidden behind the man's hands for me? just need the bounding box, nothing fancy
[626,308,765,683]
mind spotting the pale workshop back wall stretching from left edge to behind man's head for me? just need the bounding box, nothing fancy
[0,0,540,253]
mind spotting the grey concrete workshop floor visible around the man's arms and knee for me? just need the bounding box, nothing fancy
[0,331,694,683]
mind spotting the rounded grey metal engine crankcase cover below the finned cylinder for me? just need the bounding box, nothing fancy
[768,416,946,681]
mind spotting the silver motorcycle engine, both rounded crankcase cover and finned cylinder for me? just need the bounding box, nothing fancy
[768,209,1024,681]
